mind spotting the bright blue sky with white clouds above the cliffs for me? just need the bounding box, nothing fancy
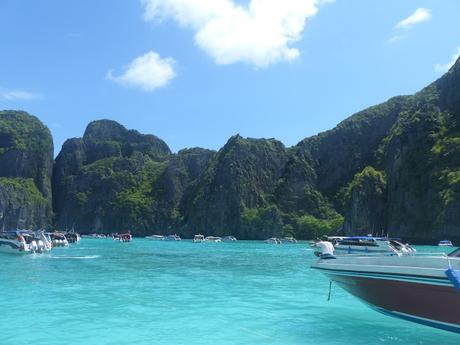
[0,0,460,154]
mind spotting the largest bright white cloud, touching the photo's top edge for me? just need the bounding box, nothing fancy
[143,0,322,67]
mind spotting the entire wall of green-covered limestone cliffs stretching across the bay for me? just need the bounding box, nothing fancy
[0,57,460,241]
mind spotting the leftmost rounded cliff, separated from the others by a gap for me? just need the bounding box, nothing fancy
[0,111,53,230]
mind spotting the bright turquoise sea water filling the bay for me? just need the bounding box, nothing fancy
[0,239,460,345]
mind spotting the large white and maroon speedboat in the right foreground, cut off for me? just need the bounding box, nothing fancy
[312,243,460,333]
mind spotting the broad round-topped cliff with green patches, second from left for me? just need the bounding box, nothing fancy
[53,120,171,233]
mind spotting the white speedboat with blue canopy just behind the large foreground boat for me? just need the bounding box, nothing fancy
[332,236,416,255]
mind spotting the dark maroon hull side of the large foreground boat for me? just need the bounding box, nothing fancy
[323,270,460,333]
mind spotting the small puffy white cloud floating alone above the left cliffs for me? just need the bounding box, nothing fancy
[107,51,176,91]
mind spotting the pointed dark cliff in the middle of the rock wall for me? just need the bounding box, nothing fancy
[182,135,287,239]
